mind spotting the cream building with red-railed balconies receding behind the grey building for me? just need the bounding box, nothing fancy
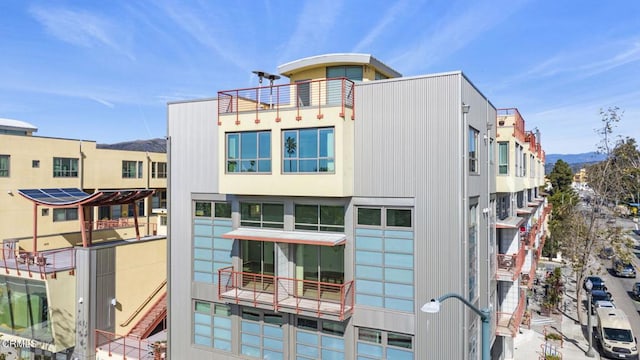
[494,108,551,359]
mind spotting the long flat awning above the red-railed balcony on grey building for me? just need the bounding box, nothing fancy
[222,228,347,246]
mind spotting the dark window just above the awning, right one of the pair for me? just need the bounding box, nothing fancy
[295,204,344,232]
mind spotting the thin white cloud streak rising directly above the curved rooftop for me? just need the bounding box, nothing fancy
[279,0,342,64]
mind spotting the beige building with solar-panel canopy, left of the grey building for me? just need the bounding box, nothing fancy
[0,119,167,359]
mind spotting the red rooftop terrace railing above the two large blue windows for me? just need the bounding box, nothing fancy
[218,78,355,125]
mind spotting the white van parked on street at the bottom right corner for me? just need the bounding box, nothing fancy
[596,308,638,360]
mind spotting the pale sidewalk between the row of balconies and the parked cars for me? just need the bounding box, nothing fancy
[513,262,600,360]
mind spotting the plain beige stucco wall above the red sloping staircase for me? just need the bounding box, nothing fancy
[115,239,167,334]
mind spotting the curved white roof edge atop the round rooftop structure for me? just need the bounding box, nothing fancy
[278,53,402,77]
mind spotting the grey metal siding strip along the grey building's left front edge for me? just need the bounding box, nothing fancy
[168,100,223,359]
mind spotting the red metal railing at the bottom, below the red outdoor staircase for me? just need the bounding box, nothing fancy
[95,330,154,360]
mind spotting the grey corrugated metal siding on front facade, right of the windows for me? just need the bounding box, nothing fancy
[354,73,466,359]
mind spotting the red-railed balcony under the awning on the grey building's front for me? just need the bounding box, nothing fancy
[218,267,354,321]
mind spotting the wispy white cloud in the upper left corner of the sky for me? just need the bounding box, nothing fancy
[29,6,135,60]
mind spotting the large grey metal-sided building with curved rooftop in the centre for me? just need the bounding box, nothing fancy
[168,54,499,359]
